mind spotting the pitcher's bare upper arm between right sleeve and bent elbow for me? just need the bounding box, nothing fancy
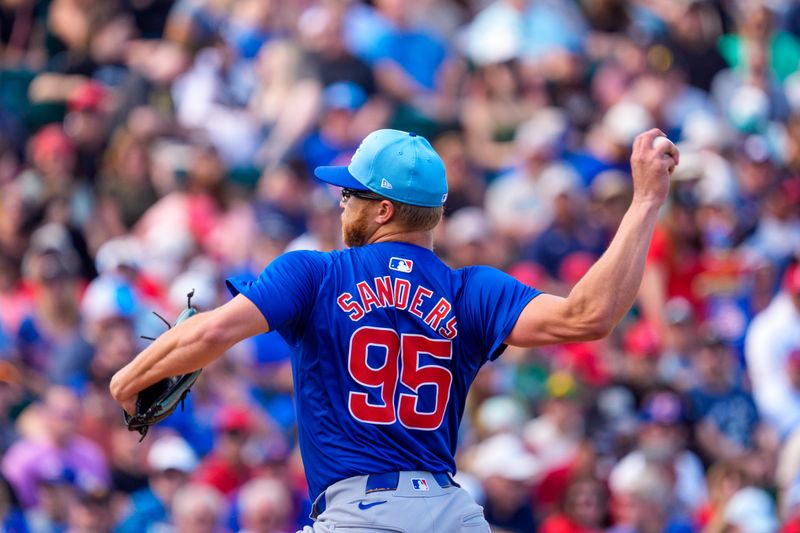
[505,294,597,347]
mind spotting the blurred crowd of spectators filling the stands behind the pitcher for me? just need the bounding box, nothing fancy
[0,0,800,533]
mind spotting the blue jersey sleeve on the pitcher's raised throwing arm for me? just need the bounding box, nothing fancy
[461,266,542,360]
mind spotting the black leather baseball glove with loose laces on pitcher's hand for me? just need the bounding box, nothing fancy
[123,290,202,442]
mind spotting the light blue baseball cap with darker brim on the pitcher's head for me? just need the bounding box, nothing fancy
[314,129,447,207]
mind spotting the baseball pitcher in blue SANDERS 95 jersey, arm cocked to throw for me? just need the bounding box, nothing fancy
[111,130,678,533]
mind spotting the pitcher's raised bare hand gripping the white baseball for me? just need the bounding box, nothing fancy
[631,128,680,205]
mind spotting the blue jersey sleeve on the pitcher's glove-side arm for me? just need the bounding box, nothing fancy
[225,251,329,337]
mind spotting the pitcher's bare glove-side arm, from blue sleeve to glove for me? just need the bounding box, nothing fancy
[110,295,269,413]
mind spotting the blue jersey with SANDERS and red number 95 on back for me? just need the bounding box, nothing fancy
[227,242,539,500]
